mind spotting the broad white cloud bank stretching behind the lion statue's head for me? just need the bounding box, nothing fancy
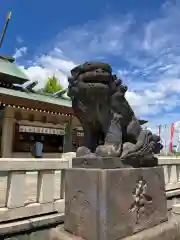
[15,1,180,132]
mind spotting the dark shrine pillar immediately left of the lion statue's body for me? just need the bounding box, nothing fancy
[63,116,72,152]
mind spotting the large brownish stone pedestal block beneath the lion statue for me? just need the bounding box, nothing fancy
[64,167,167,240]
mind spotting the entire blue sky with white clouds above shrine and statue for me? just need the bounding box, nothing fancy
[0,0,180,142]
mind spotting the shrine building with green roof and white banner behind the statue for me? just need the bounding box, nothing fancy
[0,56,146,158]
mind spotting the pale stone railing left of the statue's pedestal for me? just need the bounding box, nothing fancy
[0,158,69,222]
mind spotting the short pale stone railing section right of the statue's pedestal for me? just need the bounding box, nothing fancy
[158,156,180,196]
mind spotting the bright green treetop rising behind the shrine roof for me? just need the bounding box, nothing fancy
[43,75,63,93]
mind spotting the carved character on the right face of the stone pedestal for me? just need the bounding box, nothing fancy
[129,177,152,224]
